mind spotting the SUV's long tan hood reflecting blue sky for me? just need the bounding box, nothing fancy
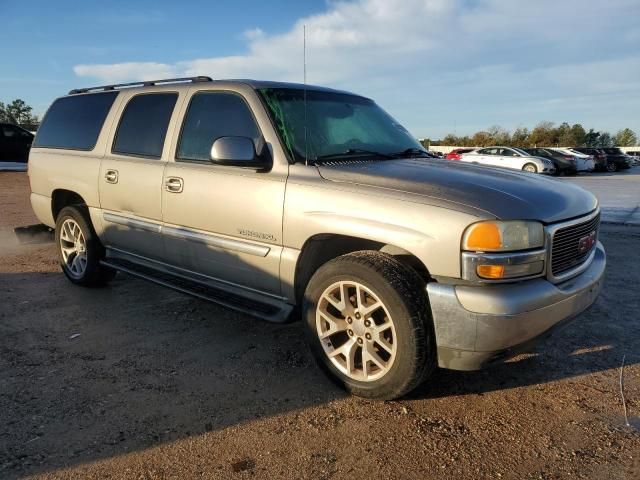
[318,158,598,223]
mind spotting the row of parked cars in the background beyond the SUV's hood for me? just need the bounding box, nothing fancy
[445,147,639,175]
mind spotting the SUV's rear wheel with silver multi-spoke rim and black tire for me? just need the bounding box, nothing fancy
[55,207,116,287]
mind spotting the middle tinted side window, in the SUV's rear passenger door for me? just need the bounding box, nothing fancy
[112,93,178,158]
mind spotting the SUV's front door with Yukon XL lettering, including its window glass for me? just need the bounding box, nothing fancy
[162,90,286,294]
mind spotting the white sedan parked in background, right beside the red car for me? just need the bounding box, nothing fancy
[460,147,556,174]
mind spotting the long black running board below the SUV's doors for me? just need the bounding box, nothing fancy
[100,258,293,323]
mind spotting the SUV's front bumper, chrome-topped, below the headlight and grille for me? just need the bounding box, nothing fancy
[427,242,606,370]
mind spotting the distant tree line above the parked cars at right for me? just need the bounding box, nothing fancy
[422,122,638,148]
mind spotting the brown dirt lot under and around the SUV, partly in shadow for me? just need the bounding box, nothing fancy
[0,173,640,479]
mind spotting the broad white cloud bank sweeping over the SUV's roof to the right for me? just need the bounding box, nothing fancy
[74,0,640,136]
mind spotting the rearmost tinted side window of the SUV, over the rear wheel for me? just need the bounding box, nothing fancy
[33,92,118,150]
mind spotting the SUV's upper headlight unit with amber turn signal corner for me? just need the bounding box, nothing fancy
[462,220,544,252]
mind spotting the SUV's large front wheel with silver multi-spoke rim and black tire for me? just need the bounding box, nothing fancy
[303,251,436,400]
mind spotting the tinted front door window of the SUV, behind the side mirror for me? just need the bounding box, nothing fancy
[176,92,260,162]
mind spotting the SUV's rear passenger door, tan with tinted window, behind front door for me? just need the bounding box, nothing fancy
[99,91,178,259]
